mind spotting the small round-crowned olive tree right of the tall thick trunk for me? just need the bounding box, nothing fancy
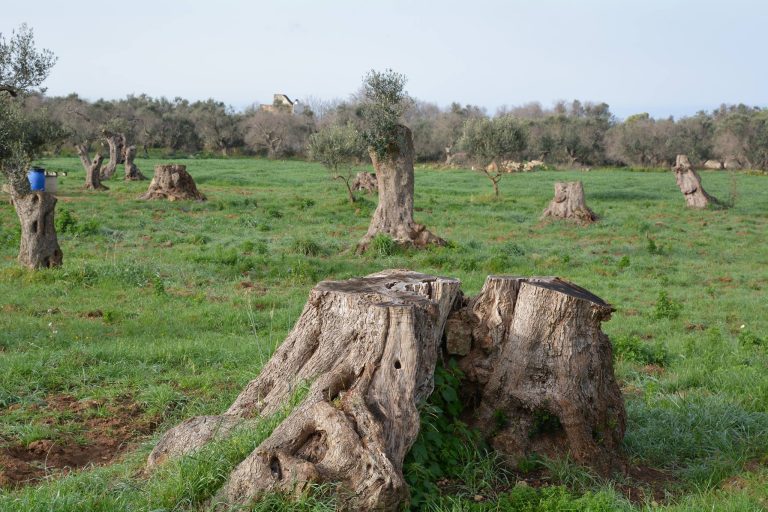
[460,116,528,197]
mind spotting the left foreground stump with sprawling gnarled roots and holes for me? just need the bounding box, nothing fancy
[149,271,459,510]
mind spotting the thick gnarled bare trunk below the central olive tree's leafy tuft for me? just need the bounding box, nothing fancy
[357,125,445,253]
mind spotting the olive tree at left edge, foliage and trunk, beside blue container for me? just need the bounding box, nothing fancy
[0,25,63,269]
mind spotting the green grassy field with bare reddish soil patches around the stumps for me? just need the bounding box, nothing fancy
[0,159,768,511]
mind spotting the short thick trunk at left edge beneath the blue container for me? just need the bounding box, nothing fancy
[11,191,64,269]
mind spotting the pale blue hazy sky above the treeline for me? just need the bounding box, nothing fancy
[0,0,768,117]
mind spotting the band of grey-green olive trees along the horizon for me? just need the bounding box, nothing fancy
[25,94,768,170]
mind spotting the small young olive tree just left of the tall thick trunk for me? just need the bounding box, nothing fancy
[309,125,362,204]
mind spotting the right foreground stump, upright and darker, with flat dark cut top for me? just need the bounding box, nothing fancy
[446,276,626,474]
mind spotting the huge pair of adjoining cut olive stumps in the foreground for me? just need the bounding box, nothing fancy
[148,270,625,511]
